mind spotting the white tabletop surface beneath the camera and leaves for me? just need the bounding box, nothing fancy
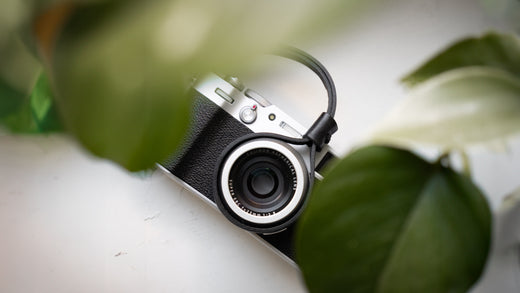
[0,0,520,292]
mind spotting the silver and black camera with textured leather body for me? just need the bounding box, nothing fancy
[160,48,337,259]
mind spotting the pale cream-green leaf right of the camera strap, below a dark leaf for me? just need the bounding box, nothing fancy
[373,67,520,150]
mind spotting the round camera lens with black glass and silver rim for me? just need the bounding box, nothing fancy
[216,138,309,231]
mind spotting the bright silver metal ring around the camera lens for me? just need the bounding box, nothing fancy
[220,139,308,224]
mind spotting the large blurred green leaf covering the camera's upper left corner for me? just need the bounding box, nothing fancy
[51,0,372,171]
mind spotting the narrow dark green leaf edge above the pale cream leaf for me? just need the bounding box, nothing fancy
[402,32,520,86]
